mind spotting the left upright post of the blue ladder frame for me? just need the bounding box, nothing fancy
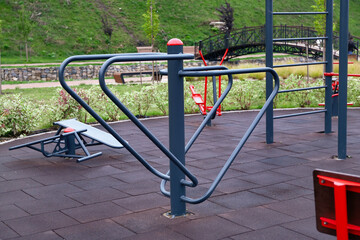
[265,0,274,143]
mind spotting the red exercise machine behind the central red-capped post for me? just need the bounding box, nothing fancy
[189,49,229,125]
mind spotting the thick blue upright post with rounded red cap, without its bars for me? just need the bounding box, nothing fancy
[167,39,186,217]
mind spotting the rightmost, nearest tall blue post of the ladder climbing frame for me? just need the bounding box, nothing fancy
[338,0,349,159]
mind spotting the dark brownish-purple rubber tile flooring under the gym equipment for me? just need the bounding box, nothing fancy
[0,109,360,240]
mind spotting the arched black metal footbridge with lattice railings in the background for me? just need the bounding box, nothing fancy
[195,25,360,61]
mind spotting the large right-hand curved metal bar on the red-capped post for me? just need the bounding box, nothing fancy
[176,67,280,204]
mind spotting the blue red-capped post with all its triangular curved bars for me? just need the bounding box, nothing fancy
[55,39,279,217]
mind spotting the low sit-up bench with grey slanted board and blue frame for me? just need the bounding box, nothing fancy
[9,119,123,162]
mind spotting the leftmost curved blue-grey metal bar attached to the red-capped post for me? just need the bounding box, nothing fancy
[59,53,188,184]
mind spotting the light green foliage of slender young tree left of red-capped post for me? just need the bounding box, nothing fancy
[142,0,160,50]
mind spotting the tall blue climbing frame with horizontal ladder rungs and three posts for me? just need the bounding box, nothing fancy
[265,0,349,159]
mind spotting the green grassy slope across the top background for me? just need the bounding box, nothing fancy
[0,0,360,63]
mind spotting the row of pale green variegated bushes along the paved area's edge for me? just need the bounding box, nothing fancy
[0,72,360,136]
